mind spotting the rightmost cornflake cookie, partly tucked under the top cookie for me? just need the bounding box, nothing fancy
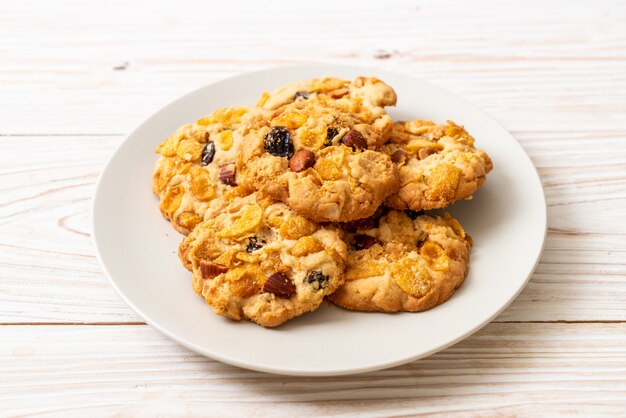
[384,120,493,210]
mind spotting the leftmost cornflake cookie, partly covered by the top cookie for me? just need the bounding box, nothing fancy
[152,107,271,235]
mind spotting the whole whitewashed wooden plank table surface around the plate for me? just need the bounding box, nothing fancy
[0,0,626,417]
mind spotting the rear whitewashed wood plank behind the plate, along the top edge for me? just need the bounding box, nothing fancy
[0,0,626,134]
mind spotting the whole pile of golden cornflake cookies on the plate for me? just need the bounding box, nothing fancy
[152,77,492,327]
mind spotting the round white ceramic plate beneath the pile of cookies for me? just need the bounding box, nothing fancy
[93,65,546,376]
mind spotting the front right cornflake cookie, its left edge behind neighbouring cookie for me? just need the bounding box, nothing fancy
[329,210,471,312]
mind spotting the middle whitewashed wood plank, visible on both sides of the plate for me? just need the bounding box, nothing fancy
[0,132,626,323]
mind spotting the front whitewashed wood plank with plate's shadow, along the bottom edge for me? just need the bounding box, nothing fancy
[0,323,626,417]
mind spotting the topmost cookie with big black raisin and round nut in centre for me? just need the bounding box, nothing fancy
[237,95,398,222]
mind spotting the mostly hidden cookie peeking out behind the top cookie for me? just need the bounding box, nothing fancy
[257,77,397,122]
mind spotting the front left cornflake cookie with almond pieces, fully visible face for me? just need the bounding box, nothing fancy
[179,195,347,327]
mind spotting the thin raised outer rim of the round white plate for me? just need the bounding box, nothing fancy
[90,62,548,377]
